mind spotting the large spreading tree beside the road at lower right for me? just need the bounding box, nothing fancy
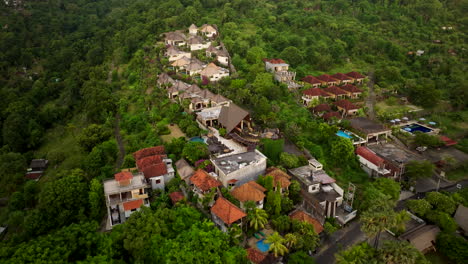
[361,200,398,248]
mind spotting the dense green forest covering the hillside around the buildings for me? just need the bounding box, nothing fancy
[0,0,468,263]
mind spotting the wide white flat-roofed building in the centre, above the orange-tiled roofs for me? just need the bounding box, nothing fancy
[211,150,267,187]
